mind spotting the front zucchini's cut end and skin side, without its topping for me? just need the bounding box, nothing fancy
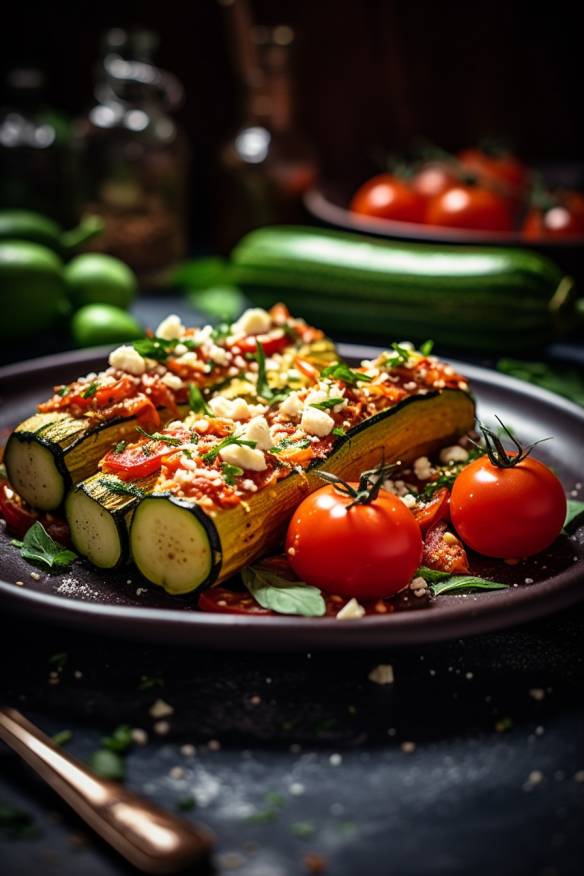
[130,389,475,594]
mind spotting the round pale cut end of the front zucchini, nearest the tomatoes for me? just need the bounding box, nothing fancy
[130,496,217,596]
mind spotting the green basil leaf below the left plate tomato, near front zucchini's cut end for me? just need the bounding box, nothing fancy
[241,566,326,617]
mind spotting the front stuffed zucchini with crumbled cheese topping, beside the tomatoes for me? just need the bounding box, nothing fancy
[130,345,474,594]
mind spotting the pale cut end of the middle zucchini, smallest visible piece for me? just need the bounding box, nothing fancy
[65,489,127,569]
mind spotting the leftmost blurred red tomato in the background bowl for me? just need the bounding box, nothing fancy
[350,173,426,222]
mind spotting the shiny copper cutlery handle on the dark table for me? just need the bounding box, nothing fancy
[0,708,214,874]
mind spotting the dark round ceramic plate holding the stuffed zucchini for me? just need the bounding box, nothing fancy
[0,345,584,650]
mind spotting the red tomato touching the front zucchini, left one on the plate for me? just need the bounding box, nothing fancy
[286,484,422,600]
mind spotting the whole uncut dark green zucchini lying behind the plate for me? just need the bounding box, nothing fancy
[231,226,582,351]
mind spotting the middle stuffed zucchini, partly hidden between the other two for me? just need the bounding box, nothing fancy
[65,307,336,568]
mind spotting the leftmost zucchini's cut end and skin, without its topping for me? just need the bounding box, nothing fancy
[4,410,184,511]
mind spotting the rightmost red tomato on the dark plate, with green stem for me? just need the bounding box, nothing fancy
[450,456,566,558]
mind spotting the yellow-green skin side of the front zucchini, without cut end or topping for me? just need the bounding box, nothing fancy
[130,389,475,590]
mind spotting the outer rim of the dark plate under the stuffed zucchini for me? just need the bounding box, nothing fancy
[0,343,584,651]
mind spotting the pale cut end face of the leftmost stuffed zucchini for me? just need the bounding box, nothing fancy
[4,434,68,511]
